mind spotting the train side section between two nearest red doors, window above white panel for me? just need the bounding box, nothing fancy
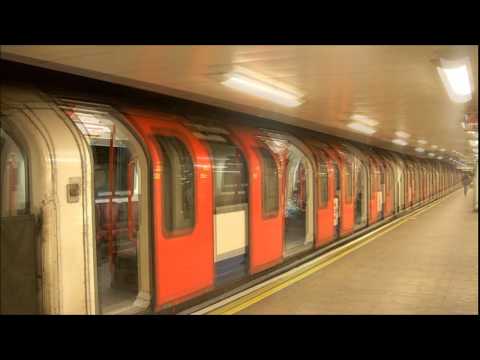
[208,140,248,284]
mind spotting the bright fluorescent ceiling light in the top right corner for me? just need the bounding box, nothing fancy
[437,59,472,103]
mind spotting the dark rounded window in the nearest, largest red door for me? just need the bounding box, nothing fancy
[156,136,195,234]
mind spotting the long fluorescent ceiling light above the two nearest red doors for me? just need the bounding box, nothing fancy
[222,74,303,107]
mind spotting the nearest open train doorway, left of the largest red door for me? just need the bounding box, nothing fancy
[61,106,150,314]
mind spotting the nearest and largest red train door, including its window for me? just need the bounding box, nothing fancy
[127,115,214,311]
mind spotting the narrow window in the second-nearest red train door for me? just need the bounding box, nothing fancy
[259,148,278,216]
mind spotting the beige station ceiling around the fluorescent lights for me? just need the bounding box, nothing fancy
[1,45,478,167]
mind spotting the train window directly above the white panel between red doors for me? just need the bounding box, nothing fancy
[210,142,248,208]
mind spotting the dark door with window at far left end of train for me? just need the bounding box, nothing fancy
[0,124,38,315]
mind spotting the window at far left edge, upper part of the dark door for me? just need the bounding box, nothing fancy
[0,128,28,217]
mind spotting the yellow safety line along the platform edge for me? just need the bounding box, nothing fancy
[207,191,455,315]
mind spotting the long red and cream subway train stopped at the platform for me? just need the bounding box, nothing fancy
[0,74,461,314]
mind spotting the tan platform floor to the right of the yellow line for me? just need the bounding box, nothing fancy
[239,189,478,314]
